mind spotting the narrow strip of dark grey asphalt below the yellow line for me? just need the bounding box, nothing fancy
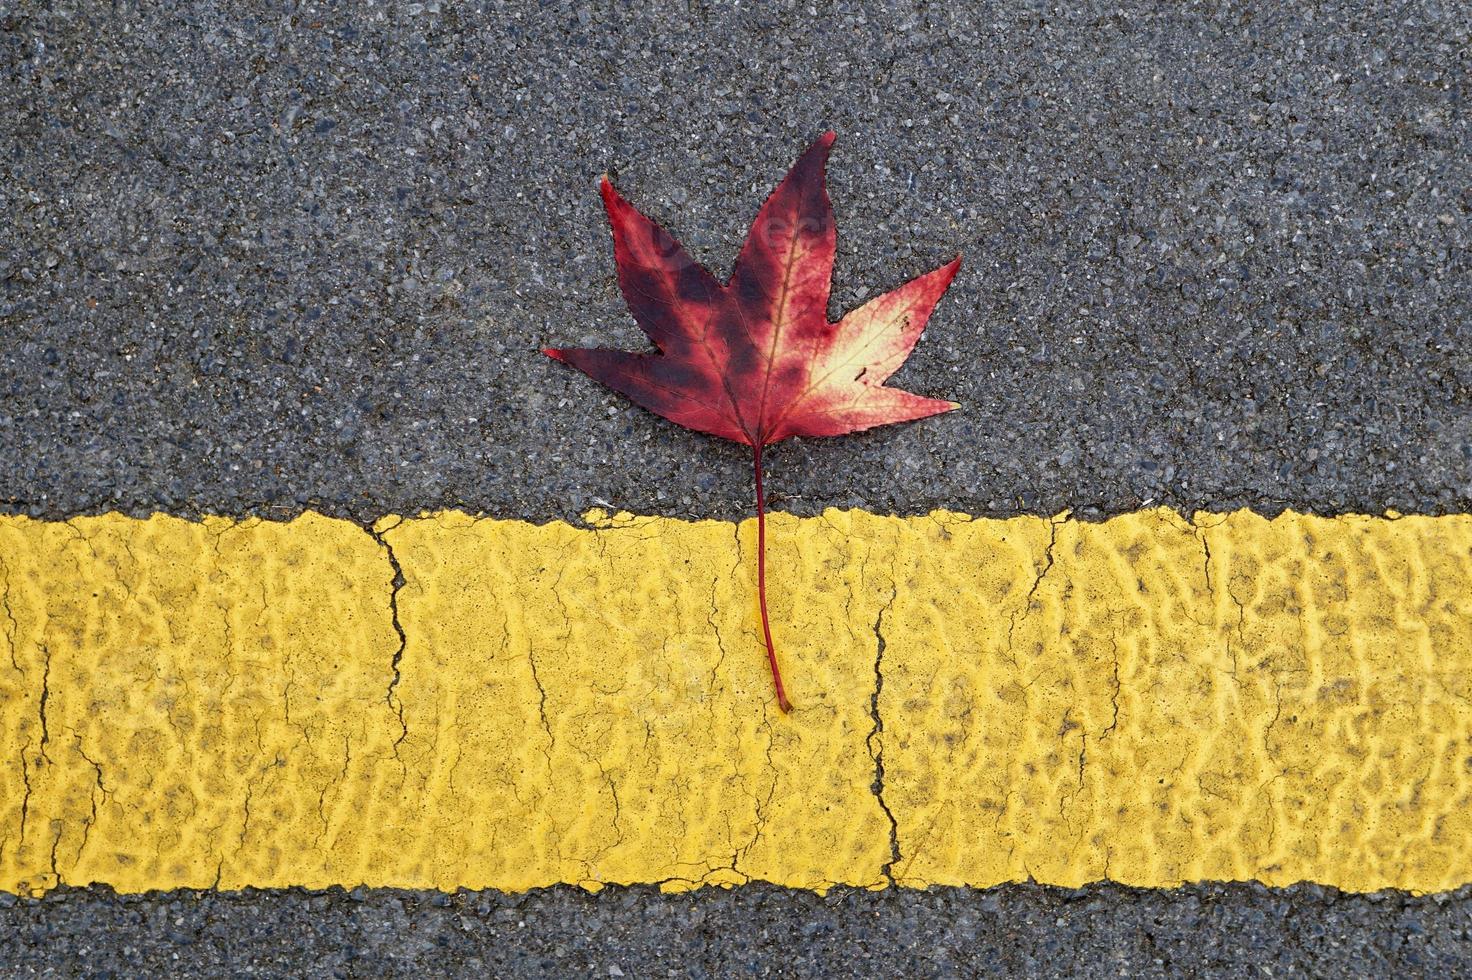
[0,884,1472,977]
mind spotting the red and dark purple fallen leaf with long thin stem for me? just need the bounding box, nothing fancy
[543,132,961,711]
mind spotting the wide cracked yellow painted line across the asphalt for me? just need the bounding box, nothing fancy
[0,511,1472,892]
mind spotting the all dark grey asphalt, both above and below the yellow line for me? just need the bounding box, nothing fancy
[0,0,1472,976]
